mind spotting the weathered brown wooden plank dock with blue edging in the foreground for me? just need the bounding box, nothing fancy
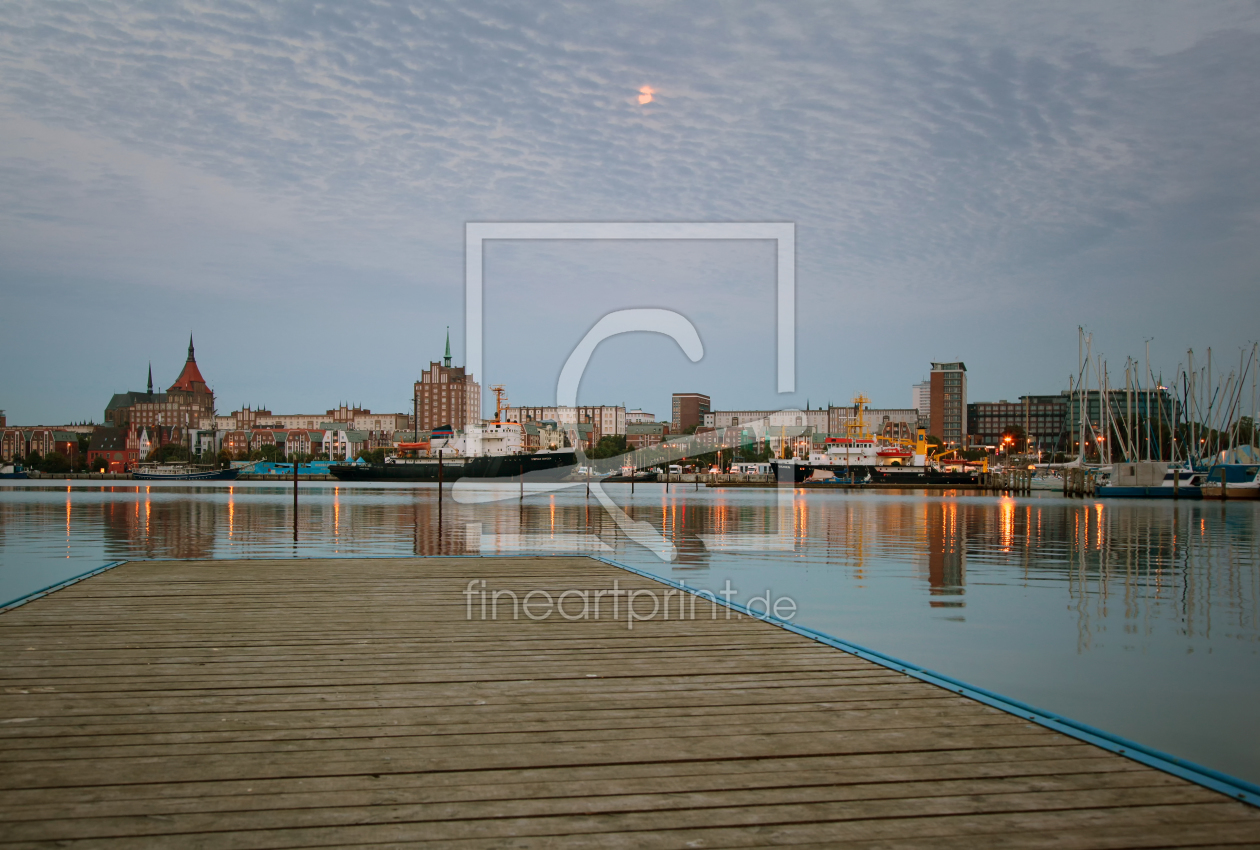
[0,558,1260,850]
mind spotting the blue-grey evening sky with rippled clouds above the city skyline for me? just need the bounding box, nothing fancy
[0,0,1260,423]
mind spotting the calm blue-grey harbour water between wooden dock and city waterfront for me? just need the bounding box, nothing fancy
[0,482,1260,782]
